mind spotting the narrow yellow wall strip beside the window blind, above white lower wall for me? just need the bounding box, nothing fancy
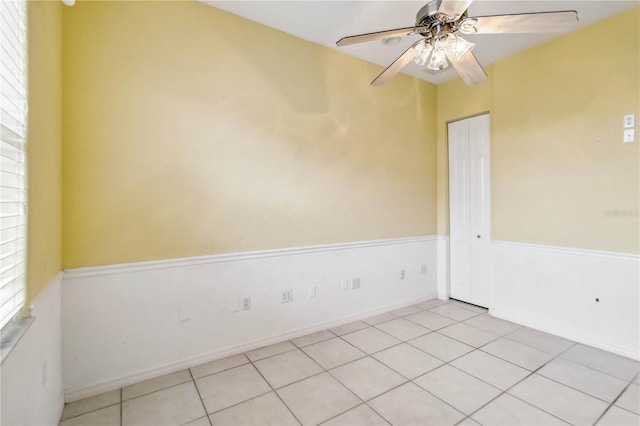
[26,1,62,306]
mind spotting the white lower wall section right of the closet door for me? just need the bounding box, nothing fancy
[490,241,640,359]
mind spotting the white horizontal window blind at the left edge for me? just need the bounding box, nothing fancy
[0,0,27,328]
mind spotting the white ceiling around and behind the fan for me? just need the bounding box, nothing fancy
[201,0,640,84]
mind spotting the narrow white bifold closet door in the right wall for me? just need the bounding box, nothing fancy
[449,114,491,307]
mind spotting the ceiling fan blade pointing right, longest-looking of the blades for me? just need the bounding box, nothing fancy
[463,10,578,34]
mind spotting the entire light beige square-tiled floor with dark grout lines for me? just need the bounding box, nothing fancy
[60,300,640,426]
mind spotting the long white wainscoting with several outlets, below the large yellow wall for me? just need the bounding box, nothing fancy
[62,236,437,401]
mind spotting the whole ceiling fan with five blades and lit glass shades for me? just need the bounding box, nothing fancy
[336,0,578,86]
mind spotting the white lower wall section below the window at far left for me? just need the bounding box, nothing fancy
[0,273,64,425]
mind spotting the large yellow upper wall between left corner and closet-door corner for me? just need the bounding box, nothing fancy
[63,2,436,267]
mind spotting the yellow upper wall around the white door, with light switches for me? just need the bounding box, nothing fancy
[438,8,640,253]
